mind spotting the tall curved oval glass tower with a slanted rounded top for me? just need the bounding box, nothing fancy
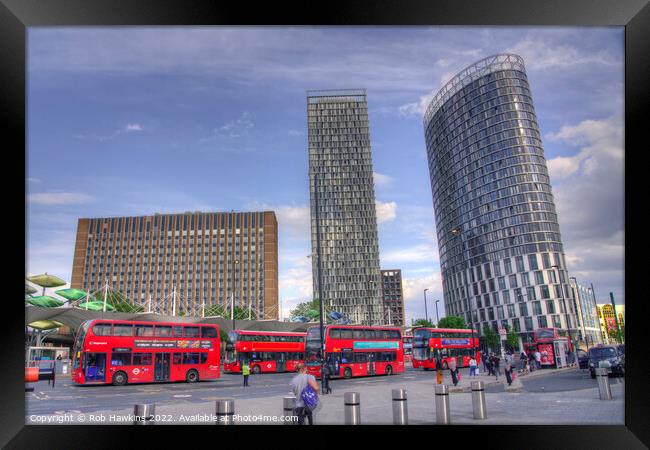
[424,54,577,342]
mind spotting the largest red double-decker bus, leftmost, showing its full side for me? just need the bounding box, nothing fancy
[72,320,221,386]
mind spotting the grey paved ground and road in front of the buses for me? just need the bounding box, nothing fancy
[26,369,624,424]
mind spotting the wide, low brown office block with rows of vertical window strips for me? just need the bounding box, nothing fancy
[71,211,278,319]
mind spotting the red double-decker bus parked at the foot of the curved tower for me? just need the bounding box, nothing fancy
[412,328,480,370]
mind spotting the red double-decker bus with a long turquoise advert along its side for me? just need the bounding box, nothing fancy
[305,325,404,378]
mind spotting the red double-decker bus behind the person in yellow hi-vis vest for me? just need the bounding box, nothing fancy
[223,330,305,374]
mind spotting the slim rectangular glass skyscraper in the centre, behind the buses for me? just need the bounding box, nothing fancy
[307,89,383,324]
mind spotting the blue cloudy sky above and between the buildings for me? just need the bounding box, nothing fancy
[26,27,625,321]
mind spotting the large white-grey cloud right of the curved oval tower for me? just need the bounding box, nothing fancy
[547,117,625,301]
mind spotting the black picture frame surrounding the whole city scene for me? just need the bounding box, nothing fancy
[0,0,650,449]
